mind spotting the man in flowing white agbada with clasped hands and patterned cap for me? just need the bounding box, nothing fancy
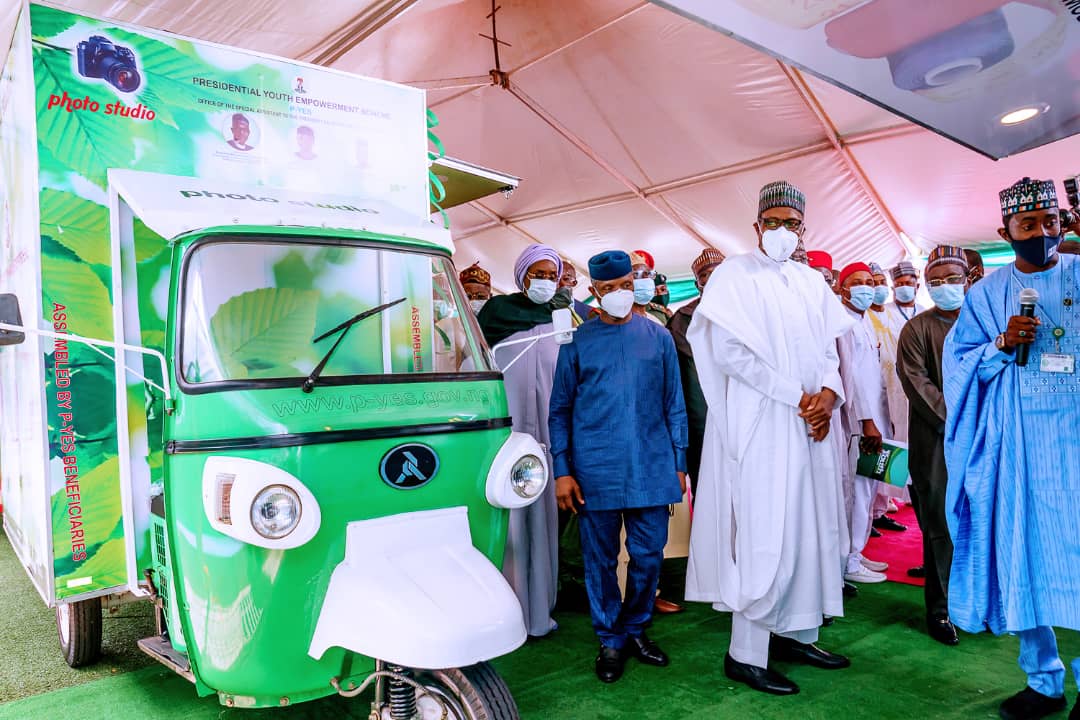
[686,182,854,695]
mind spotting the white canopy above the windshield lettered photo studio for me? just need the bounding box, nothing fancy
[109,169,454,253]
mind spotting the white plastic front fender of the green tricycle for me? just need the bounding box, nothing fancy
[308,507,526,668]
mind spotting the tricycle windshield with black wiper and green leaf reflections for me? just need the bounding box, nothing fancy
[179,237,494,389]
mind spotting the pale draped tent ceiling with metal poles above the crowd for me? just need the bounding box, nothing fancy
[8,0,1080,288]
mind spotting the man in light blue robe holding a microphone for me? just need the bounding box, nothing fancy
[943,178,1080,720]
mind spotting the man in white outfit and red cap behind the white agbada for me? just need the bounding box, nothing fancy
[838,262,889,583]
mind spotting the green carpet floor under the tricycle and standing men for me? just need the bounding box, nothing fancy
[0,526,1080,720]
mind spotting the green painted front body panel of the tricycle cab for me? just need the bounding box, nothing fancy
[158,228,510,707]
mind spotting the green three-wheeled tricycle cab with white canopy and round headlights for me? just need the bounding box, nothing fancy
[0,171,548,720]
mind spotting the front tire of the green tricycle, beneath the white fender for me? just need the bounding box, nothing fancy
[408,663,519,720]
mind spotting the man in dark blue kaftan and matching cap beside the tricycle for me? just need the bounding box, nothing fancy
[548,250,687,682]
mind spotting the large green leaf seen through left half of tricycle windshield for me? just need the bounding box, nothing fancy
[210,287,319,378]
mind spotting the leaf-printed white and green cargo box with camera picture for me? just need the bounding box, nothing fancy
[0,4,429,604]
